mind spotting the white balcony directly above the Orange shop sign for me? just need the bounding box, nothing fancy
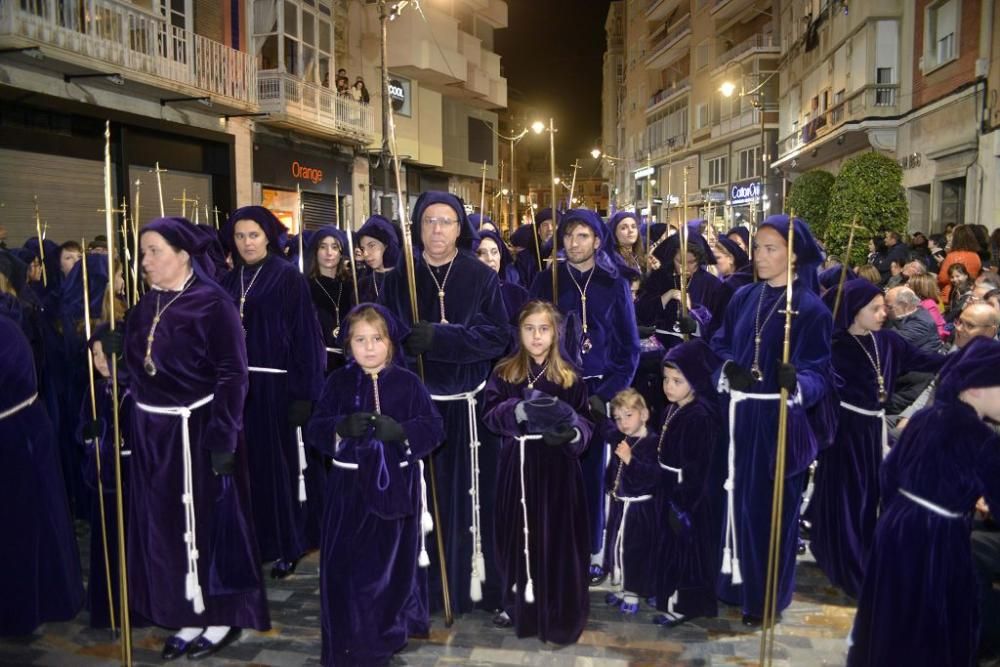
[257,70,375,145]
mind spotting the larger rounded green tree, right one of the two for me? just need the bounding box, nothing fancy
[825,151,910,265]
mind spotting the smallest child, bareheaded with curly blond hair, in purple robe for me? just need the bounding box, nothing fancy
[604,389,660,614]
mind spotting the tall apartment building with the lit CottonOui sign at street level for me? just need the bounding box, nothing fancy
[619,0,781,226]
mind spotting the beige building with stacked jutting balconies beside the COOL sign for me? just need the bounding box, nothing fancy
[345,0,507,222]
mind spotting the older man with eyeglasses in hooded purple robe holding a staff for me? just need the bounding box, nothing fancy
[381,191,510,612]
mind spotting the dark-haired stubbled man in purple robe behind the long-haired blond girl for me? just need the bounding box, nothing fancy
[530,209,639,585]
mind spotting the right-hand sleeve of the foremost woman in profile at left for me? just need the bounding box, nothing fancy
[202,298,249,452]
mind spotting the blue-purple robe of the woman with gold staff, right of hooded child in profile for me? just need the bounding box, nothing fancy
[711,281,833,616]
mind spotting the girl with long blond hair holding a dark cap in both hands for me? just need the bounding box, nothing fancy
[483,301,592,644]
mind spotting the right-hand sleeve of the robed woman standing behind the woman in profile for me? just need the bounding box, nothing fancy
[282,274,326,408]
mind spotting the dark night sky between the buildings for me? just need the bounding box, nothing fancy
[494,0,611,169]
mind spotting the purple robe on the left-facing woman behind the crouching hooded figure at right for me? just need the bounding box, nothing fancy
[806,330,947,597]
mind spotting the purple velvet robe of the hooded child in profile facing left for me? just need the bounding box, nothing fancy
[654,397,723,617]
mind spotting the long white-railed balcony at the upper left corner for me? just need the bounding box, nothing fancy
[0,0,257,109]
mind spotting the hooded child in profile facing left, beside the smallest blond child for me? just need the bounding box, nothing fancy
[653,339,722,627]
